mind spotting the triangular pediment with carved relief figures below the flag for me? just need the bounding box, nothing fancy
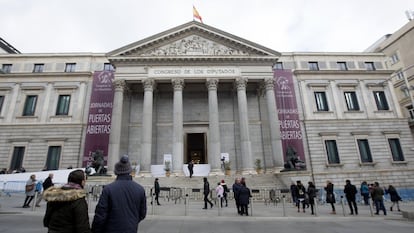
[107,21,280,60]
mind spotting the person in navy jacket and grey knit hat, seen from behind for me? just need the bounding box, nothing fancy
[92,155,147,233]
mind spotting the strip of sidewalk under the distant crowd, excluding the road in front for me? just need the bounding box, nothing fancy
[0,193,414,221]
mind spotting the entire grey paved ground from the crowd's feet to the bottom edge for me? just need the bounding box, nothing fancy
[0,193,414,233]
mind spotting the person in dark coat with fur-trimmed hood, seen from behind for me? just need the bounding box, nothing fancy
[43,169,91,233]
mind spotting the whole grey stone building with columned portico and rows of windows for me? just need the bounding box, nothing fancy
[0,21,414,187]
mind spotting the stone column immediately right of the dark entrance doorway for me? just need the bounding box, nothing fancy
[206,78,221,172]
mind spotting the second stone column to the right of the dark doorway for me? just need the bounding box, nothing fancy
[236,77,253,173]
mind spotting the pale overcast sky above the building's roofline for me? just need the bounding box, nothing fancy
[0,0,414,53]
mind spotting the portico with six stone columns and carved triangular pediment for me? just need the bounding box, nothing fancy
[108,22,283,176]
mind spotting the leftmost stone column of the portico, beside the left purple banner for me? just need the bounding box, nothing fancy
[107,80,126,174]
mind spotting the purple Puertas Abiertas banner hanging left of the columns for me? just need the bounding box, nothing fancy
[82,71,114,167]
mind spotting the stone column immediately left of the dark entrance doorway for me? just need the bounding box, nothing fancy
[171,78,184,174]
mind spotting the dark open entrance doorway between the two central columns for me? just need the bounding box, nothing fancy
[184,133,208,164]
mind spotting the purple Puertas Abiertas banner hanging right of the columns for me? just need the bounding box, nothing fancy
[273,70,305,165]
